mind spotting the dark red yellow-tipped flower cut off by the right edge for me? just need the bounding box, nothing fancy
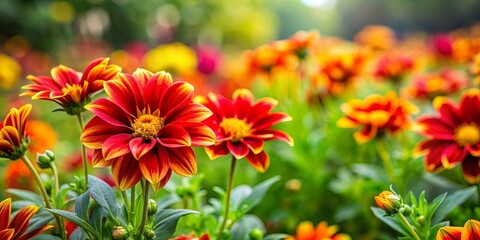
[417,89,480,184]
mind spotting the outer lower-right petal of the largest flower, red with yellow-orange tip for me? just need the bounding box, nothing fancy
[167,147,197,176]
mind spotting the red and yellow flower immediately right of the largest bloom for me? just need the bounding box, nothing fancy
[197,89,293,172]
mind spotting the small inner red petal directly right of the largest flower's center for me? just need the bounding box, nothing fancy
[157,124,192,148]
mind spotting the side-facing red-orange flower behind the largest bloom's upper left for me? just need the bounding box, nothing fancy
[20,58,122,115]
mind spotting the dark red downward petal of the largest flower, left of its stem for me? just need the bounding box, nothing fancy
[111,154,143,191]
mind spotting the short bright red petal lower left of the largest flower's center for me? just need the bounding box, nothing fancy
[102,133,132,161]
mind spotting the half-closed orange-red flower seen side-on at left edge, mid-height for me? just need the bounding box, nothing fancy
[0,104,32,160]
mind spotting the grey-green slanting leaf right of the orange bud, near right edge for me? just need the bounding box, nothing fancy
[432,186,476,224]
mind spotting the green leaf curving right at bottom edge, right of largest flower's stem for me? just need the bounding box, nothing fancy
[153,209,198,240]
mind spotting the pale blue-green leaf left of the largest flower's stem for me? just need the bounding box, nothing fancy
[88,175,120,217]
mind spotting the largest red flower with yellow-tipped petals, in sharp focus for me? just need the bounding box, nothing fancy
[80,69,215,190]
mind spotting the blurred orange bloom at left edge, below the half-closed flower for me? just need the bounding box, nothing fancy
[3,161,35,190]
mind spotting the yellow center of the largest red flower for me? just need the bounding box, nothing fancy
[132,114,163,139]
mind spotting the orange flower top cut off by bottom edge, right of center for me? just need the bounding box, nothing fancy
[287,221,351,240]
